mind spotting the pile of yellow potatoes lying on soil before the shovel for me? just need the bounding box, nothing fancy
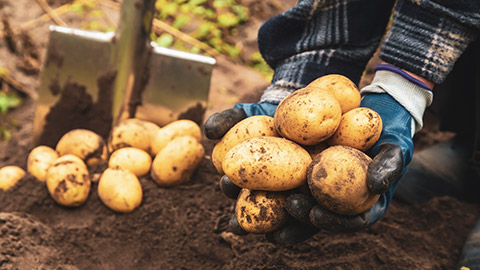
[0,118,205,213]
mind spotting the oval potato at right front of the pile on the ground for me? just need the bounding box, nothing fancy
[150,135,205,186]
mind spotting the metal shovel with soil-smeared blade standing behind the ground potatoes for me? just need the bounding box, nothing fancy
[33,0,215,147]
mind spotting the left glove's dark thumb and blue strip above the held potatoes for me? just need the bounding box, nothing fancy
[204,102,278,140]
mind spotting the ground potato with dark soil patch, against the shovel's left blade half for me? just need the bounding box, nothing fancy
[55,129,108,166]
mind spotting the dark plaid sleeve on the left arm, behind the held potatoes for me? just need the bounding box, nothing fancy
[258,0,394,103]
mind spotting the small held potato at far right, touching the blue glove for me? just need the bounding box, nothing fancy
[328,107,382,151]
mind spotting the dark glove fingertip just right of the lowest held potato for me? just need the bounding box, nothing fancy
[285,194,316,224]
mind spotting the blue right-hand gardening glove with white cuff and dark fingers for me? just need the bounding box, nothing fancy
[274,65,433,243]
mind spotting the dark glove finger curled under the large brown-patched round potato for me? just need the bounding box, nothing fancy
[310,205,370,232]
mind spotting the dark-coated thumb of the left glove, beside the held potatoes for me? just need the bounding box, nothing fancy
[203,108,247,140]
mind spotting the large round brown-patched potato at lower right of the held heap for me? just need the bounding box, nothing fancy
[307,145,380,215]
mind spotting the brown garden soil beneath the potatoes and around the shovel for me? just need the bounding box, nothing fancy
[0,0,480,269]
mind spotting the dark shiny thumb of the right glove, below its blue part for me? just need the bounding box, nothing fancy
[367,144,403,194]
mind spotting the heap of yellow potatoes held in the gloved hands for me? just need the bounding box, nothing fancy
[212,74,382,233]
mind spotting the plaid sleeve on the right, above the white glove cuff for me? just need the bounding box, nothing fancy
[380,0,480,83]
